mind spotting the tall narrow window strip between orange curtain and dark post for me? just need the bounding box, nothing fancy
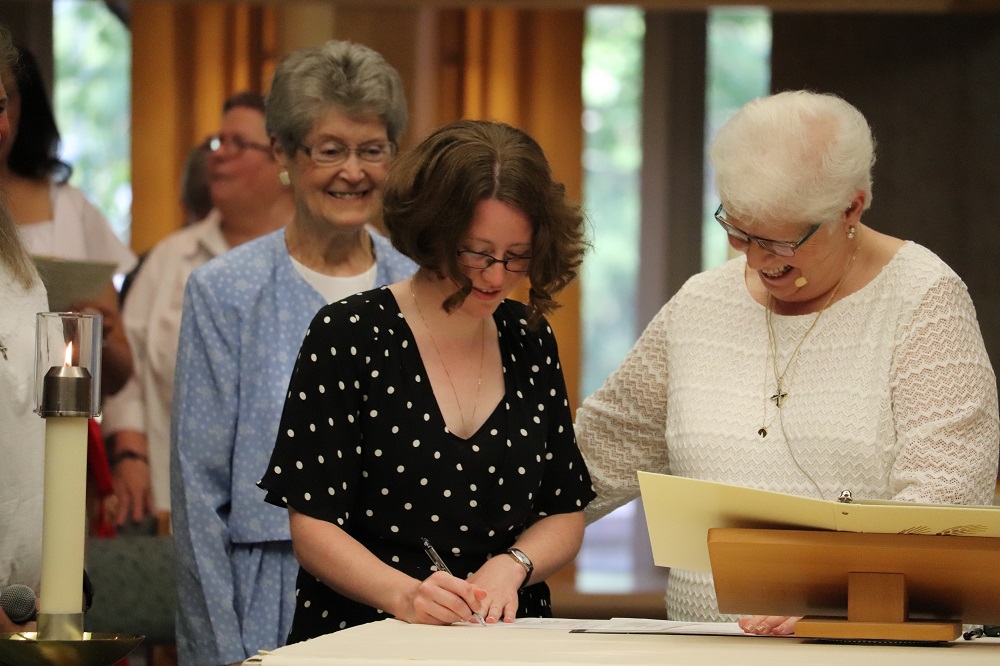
[580,6,645,396]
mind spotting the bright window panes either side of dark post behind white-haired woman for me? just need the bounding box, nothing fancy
[576,6,771,593]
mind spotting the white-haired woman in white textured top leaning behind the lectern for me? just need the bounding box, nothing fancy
[576,91,998,634]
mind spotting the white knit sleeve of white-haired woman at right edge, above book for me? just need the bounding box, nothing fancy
[890,274,1000,504]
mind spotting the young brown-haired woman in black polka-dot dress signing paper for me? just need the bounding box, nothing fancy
[260,121,593,642]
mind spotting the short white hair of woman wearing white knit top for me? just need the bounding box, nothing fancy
[709,90,875,225]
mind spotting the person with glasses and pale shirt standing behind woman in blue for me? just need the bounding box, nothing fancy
[104,92,295,524]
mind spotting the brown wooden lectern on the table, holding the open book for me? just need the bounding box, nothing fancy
[708,527,1000,642]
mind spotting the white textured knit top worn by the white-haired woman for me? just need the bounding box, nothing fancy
[576,243,1000,621]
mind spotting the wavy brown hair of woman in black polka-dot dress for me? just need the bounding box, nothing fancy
[383,120,589,326]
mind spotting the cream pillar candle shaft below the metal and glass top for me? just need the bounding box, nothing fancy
[38,417,87,615]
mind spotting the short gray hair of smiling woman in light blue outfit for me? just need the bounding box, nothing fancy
[265,40,407,154]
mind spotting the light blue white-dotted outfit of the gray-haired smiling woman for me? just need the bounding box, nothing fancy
[170,229,416,664]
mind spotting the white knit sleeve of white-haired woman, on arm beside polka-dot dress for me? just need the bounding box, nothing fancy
[576,308,669,523]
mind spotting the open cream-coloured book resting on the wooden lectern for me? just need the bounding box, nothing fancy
[638,472,1000,573]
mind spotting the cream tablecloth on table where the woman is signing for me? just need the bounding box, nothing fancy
[250,620,1000,666]
